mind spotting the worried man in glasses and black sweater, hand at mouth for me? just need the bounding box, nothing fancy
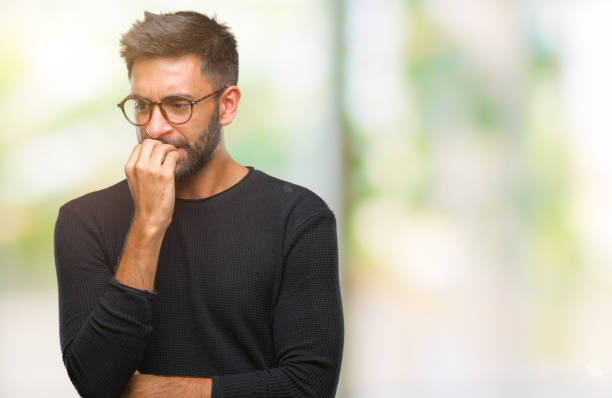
[55,12,343,398]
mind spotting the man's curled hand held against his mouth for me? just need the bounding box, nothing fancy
[125,139,178,229]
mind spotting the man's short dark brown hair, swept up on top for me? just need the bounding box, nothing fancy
[120,11,238,88]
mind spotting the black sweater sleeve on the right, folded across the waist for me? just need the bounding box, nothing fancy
[212,209,344,398]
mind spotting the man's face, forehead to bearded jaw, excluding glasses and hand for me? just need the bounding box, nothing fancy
[130,54,221,181]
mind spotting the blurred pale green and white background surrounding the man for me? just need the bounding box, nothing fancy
[0,0,612,397]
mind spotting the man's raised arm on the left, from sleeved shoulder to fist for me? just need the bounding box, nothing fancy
[54,143,176,397]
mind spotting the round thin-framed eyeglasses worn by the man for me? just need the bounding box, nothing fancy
[117,86,228,126]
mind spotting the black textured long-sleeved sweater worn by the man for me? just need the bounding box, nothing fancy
[54,167,344,398]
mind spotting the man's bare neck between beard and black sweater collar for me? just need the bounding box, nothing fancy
[175,141,248,199]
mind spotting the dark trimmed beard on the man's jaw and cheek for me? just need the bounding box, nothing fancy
[160,103,222,182]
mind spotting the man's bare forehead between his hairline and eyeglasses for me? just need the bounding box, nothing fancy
[130,54,212,99]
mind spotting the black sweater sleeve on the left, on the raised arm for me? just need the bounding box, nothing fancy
[54,205,155,397]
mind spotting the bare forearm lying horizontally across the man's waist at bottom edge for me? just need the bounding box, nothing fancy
[121,373,212,398]
